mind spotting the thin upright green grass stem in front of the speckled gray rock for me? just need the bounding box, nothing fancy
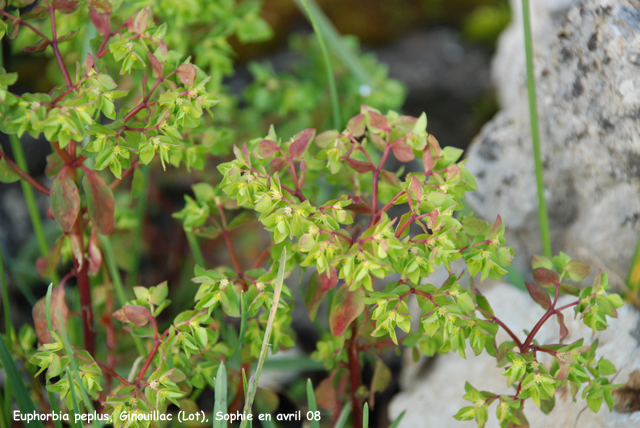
[522,0,552,257]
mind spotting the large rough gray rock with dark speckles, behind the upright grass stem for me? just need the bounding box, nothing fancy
[467,0,640,286]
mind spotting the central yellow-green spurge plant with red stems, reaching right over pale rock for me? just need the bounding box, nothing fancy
[176,106,622,427]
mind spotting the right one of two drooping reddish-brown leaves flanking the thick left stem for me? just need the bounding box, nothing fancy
[82,170,114,235]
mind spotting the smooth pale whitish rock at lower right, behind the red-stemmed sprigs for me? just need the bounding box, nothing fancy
[389,283,640,428]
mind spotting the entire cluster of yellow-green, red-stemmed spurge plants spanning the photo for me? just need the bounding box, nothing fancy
[0,0,622,427]
